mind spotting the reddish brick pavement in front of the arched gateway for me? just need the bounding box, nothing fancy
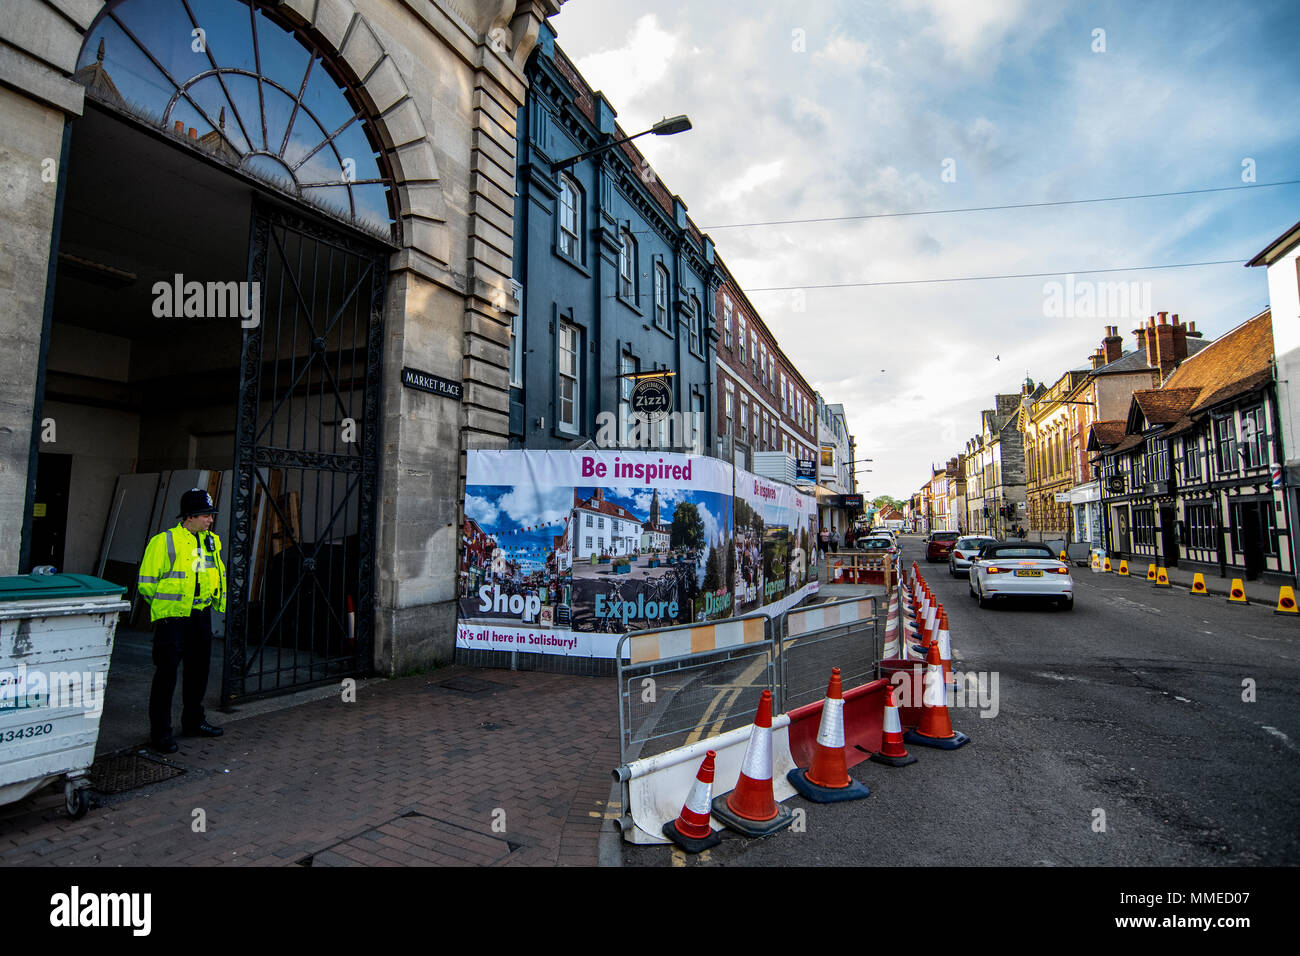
[0,667,619,866]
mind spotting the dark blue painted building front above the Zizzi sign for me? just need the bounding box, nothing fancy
[511,25,722,449]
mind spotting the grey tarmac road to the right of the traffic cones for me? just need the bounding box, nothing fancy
[637,537,1300,866]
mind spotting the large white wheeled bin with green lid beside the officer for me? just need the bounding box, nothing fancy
[0,574,130,819]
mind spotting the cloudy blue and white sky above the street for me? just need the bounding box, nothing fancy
[551,0,1300,497]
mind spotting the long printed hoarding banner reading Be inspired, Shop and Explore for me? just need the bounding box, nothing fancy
[456,449,816,658]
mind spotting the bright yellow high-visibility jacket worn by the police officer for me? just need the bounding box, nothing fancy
[138,524,226,623]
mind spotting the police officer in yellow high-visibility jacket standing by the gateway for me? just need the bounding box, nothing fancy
[139,488,226,753]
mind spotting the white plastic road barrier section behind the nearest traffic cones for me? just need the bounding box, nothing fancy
[615,714,794,844]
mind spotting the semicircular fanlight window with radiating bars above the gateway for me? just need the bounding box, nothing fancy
[75,0,394,238]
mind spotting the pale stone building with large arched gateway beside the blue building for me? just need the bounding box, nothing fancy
[0,0,562,696]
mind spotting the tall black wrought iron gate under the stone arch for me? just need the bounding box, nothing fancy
[221,203,387,701]
